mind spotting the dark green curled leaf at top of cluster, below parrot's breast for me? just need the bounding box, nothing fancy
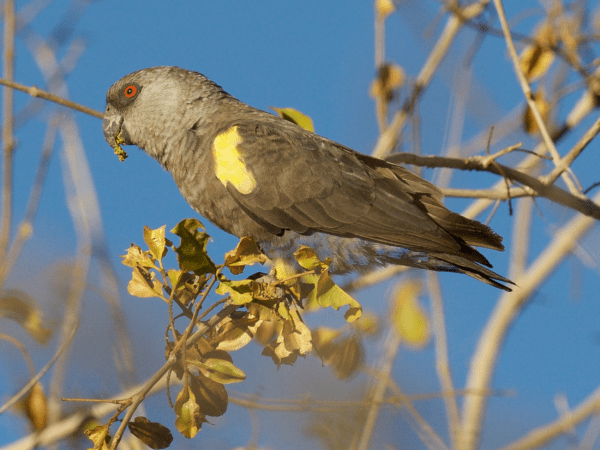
[171,219,217,275]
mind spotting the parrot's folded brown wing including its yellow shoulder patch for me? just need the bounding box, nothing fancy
[213,118,502,265]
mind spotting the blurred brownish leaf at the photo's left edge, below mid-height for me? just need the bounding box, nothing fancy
[0,289,52,344]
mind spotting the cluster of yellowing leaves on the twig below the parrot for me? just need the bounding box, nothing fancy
[87,219,363,449]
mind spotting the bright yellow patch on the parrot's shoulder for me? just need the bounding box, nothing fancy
[212,125,256,194]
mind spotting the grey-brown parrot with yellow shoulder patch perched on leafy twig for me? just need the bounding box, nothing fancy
[103,66,514,291]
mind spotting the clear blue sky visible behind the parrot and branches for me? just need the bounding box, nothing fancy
[0,0,600,448]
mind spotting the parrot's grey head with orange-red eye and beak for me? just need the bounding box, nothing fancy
[102,66,223,165]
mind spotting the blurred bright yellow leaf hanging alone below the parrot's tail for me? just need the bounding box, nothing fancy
[392,281,429,347]
